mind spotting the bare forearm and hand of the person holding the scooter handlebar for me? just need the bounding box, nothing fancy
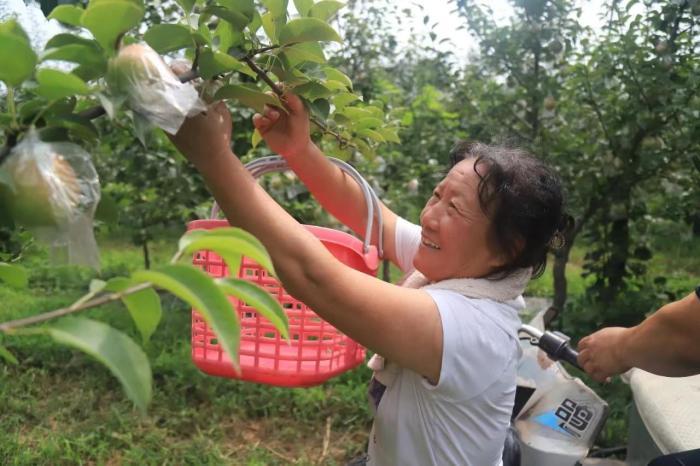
[578,293,700,380]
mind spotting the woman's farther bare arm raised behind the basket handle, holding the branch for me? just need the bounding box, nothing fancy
[253,94,396,263]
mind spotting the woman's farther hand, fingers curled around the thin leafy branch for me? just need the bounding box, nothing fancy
[253,93,311,158]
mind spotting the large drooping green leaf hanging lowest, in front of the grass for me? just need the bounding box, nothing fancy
[46,317,152,412]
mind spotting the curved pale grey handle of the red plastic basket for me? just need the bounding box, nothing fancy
[210,155,384,257]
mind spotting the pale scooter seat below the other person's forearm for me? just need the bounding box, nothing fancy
[627,369,700,454]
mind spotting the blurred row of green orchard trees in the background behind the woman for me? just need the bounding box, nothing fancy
[5,0,700,327]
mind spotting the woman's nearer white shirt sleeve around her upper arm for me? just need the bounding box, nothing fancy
[421,290,517,400]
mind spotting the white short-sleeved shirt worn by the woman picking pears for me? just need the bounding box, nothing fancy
[367,219,524,466]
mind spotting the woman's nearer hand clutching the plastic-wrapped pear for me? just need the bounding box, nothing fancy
[169,102,232,167]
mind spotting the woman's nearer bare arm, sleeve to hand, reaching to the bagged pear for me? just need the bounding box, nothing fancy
[173,104,443,381]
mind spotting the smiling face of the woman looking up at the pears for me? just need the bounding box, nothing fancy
[413,159,505,282]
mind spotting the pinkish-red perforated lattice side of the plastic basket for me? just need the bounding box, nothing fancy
[192,245,365,386]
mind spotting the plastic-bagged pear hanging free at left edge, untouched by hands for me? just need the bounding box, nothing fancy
[0,130,100,268]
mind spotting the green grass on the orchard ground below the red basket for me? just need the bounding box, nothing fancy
[0,235,370,465]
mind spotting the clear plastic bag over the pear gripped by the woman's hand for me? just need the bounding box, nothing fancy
[106,44,206,134]
